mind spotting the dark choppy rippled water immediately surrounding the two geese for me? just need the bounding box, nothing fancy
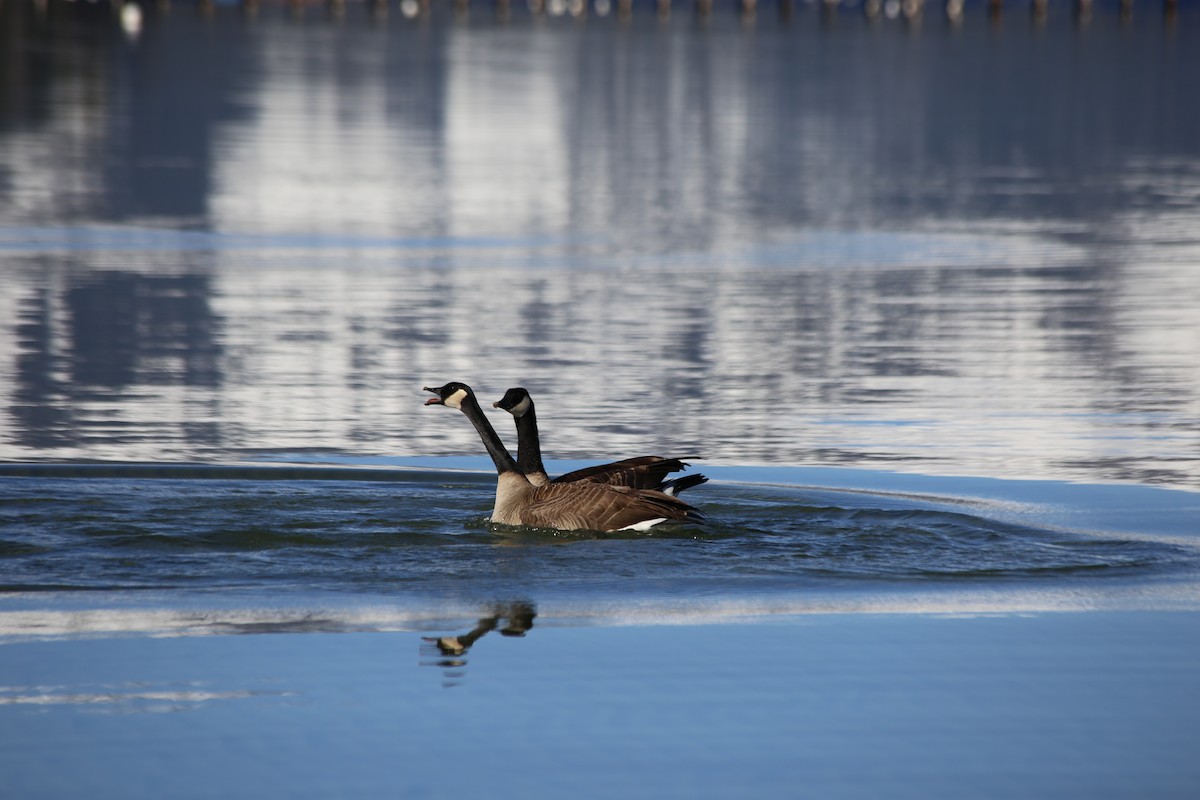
[0,477,1192,597]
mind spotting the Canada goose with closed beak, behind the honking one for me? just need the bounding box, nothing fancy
[492,386,708,494]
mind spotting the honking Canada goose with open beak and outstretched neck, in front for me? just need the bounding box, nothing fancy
[425,381,703,531]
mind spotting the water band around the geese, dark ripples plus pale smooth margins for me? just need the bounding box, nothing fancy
[0,459,1200,638]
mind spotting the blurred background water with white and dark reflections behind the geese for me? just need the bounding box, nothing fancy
[0,0,1200,488]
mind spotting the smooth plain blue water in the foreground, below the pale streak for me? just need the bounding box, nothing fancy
[0,613,1200,799]
